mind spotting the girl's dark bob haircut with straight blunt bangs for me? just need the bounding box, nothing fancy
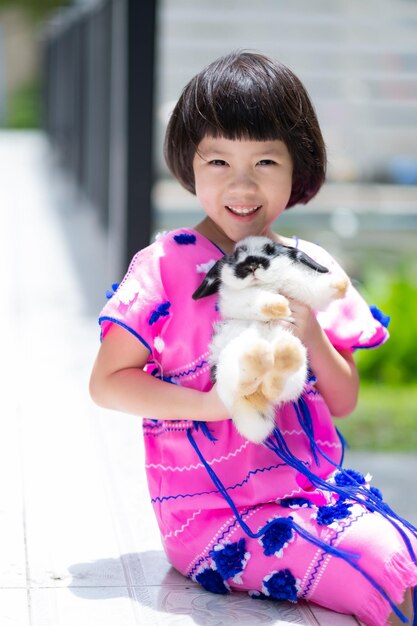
[164,52,326,208]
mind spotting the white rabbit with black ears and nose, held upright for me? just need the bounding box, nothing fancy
[192,236,350,443]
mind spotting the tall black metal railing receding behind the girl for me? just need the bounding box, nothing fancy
[43,0,156,269]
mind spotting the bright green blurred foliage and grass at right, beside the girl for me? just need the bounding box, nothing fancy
[336,258,417,452]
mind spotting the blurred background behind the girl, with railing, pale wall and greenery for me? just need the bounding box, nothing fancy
[0,0,417,452]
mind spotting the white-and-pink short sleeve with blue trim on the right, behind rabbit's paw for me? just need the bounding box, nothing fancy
[299,241,389,351]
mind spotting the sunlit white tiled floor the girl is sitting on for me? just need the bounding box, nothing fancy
[0,129,415,626]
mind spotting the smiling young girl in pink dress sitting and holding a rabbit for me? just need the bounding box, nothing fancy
[91,52,417,626]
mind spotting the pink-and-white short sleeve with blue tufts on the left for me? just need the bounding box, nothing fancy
[99,241,171,352]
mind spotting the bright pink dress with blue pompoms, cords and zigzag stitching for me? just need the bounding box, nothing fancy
[99,229,417,626]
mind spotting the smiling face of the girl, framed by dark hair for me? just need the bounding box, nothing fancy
[193,136,293,247]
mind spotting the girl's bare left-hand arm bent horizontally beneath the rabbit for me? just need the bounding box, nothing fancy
[90,324,230,422]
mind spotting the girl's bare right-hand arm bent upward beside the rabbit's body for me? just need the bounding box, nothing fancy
[290,300,359,417]
